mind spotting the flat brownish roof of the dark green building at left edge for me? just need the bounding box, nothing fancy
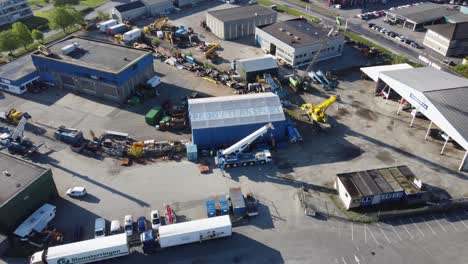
[0,153,48,206]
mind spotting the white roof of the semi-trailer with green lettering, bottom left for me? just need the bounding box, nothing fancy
[43,233,127,258]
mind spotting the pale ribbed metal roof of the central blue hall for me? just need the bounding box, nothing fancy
[188,93,286,129]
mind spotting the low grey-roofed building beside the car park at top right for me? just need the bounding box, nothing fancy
[386,3,458,31]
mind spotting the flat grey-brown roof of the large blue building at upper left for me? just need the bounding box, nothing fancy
[33,36,151,73]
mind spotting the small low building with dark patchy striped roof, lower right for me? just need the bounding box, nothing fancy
[335,166,429,209]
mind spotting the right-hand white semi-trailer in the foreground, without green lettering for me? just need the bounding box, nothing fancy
[159,215,232,248]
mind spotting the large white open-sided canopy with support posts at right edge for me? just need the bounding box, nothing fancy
[379,67,468,170]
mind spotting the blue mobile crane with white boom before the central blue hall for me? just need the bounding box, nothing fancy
[216,123,275,170]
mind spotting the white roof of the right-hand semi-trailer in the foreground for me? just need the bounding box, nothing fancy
[159,215,231,238]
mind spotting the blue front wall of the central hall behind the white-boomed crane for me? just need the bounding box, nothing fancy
[192,121,287,148]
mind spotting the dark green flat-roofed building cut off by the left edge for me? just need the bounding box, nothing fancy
[0,153,58,233]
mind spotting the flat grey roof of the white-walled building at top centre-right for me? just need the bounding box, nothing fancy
[259,18,338,48]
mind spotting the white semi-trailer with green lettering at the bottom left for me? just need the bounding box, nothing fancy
[30,233,129,264]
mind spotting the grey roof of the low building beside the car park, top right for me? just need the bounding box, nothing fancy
[388,3,458,24]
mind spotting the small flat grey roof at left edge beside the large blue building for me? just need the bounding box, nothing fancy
[0,54,36,81]
